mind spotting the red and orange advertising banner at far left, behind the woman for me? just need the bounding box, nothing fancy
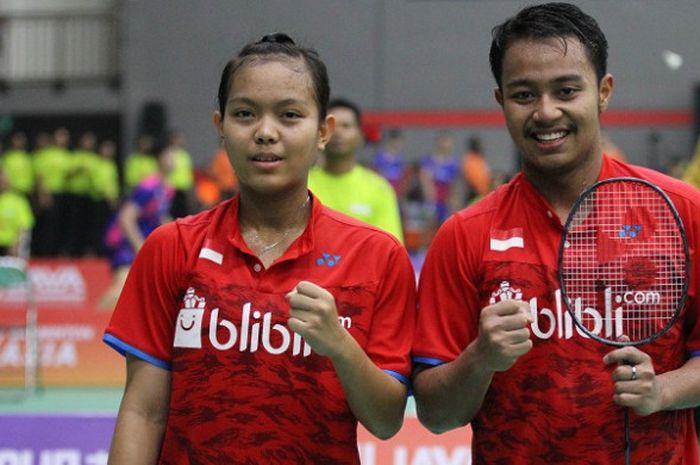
[0,259,125,387]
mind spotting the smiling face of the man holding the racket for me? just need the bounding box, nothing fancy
[496,38,613,176]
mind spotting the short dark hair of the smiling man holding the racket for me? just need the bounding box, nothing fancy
[489,3,608,88]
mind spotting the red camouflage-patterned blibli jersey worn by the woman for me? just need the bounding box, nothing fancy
[104,191,415,465]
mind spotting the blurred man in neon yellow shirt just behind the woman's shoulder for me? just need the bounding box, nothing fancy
[309,99,403,242]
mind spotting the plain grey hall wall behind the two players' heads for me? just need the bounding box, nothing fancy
[0,0,700,174]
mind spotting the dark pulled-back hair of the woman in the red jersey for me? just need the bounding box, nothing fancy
[218,32,331,121]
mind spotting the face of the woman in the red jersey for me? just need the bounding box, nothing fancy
[214,59,334,194]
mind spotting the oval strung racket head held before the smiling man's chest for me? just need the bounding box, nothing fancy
[558,177,690,346]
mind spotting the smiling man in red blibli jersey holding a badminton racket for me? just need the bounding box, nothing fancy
[413,3,700,465]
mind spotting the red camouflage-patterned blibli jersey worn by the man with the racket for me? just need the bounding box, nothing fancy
[413,157,700,465]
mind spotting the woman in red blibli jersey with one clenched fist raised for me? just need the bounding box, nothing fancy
[105,34,415,464]
